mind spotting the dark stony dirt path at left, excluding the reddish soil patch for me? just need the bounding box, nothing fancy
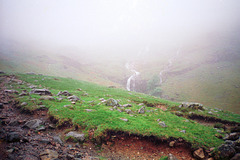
[0,77,98,160]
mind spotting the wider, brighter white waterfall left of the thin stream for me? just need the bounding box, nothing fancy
[125,63,140,91]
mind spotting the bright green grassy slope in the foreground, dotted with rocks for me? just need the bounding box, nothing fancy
[3,74,239,148]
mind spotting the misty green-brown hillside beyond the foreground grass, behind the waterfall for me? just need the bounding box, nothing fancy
[0,37,240,113]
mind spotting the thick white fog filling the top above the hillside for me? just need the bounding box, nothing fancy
[0,0,240,57]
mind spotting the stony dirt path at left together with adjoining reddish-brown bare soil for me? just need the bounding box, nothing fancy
[0,76,192,160]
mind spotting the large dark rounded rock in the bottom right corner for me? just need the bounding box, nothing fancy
[218,144,236,159]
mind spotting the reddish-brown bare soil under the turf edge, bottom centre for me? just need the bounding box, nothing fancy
[100,134,192,160]
